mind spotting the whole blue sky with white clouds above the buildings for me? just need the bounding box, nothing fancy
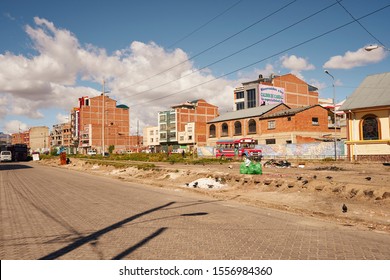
[0,0,390,134]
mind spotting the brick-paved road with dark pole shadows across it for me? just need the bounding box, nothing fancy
[0,162,390,260]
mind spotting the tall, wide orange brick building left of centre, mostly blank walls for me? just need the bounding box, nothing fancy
[75,94,130,153]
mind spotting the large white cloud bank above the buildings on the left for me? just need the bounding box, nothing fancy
[0,17,238,133]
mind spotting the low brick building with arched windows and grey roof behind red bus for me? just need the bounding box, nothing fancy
[207,103,334,146]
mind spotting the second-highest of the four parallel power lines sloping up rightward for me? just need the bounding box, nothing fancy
[118,0,298,91]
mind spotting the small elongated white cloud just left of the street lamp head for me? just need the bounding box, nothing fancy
[323,48,386,69]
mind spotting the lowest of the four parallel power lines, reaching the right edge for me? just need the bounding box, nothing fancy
[131,4,390,107]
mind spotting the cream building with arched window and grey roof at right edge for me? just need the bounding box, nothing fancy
[340,72,390,161]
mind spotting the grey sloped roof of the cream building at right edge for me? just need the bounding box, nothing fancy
[339,72,390,111]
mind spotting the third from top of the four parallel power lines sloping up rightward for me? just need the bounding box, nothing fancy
[132,0,337,97]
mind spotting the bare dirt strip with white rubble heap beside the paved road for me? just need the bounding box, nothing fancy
[39,159,390,233]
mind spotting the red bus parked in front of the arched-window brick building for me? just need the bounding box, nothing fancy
[216,138,263,161]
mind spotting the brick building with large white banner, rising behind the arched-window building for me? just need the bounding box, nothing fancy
[234,74,318,110]
